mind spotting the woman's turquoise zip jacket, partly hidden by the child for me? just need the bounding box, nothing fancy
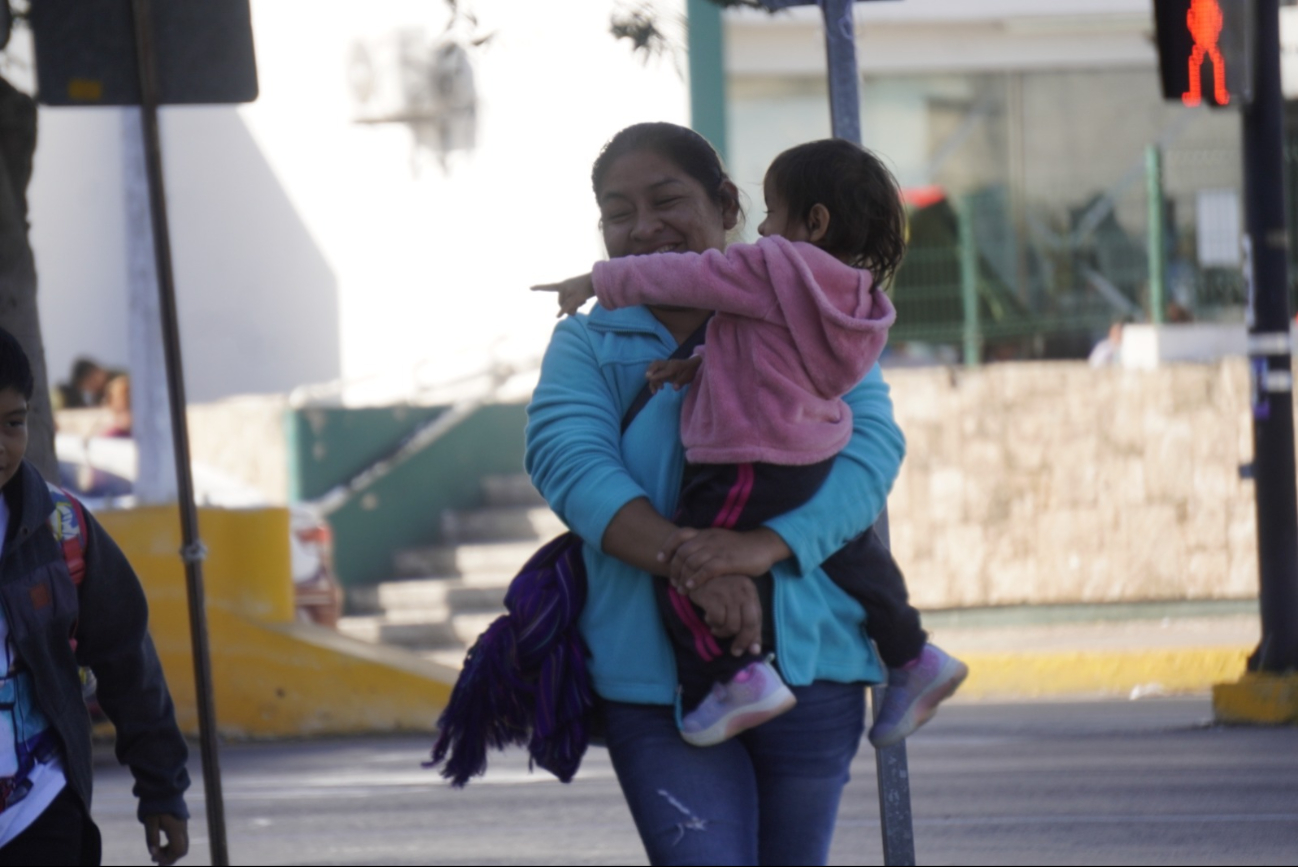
[527,306,906,705]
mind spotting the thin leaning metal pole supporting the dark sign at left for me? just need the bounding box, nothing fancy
[132,0,230,867]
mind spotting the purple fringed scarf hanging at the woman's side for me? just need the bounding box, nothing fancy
[424,533,594,788]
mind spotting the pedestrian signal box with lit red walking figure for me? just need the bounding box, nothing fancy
[1154,0,1253,106]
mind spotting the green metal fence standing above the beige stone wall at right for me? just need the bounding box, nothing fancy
[892,141,1298,363]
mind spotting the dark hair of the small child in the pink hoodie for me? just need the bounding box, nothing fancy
[766,139,906,286]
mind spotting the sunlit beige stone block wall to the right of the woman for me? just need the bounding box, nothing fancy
[887,358,1258,609]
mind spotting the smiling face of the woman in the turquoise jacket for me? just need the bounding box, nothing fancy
[598,149,739,258]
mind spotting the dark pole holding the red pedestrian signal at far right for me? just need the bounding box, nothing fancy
[1243,0,1298,672]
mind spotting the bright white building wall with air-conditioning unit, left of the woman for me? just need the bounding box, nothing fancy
[22,0,688,400]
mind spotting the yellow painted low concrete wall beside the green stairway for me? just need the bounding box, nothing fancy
[99,506,458,737]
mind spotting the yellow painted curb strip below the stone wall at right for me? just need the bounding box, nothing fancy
[955,648,1250,698]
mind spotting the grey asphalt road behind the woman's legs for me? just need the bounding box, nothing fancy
[93,697,1298,864]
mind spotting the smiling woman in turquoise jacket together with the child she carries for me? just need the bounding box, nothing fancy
[527,123,963,864]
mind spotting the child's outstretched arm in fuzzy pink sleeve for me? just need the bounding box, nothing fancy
[591,244,778,319]
